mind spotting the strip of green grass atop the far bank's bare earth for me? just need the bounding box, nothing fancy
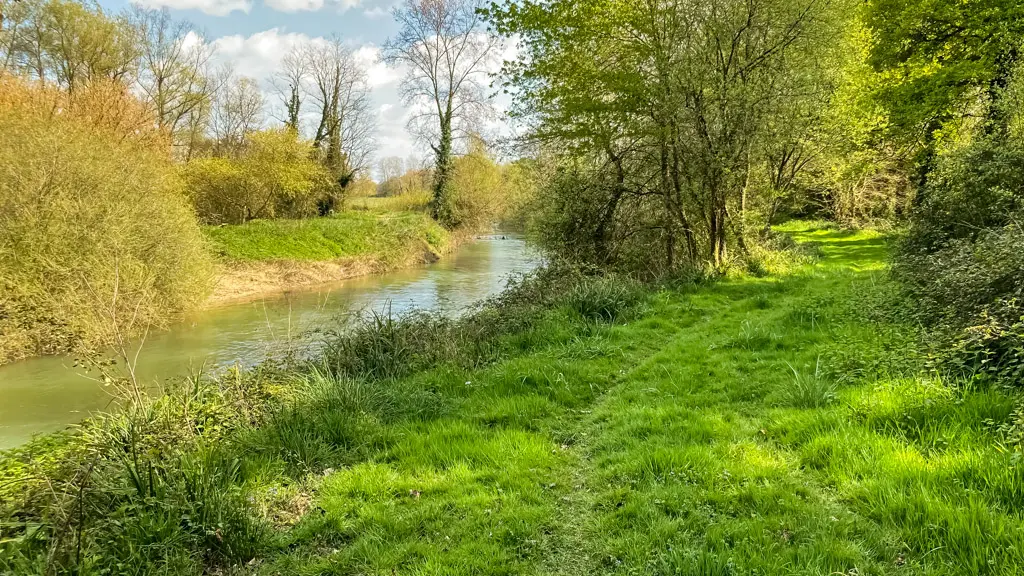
[204,211,447,261]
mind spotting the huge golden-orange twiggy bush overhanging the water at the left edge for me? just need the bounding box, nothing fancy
[0,78,212,362]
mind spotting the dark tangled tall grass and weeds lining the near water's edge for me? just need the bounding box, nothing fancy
[0,262,641,574]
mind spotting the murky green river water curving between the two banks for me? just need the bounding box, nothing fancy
[0,236,540,450]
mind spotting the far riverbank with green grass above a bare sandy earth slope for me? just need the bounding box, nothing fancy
[204,211,454,306]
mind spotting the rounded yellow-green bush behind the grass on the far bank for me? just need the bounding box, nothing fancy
[182,129,342,224]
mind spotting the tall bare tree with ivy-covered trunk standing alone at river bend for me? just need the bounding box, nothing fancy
[384,0,500,224]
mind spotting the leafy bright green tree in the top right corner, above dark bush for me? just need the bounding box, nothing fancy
[864,0,1024,192]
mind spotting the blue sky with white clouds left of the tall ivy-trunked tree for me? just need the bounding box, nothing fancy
[99,0,444,170]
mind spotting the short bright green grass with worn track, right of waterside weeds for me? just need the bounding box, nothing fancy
[260,225,1024,575]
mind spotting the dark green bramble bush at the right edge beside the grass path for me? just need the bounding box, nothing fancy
[893,135,1024,382]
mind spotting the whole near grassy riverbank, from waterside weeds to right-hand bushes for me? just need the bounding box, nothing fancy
[0,225,1024,575]
